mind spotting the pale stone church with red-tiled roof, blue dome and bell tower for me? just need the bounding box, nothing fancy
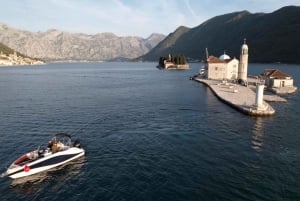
[204,39,248,81]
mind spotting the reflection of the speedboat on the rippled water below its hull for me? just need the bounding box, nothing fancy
[10,157,85,196]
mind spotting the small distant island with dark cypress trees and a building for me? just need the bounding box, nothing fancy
[157,54,190,70]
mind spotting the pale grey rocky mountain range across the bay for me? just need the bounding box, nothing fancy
[0,24,165,61]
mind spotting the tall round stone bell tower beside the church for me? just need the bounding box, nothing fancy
[238,39,248,81]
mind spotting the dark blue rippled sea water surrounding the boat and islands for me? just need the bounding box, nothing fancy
[0,62,300,201]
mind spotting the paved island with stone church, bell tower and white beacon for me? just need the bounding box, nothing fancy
[191,39,297,116]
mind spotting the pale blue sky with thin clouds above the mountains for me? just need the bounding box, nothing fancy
[0,0,300,38]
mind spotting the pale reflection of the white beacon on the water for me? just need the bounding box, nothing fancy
[251,117,264,151]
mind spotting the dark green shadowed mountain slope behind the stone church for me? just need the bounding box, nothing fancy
[139,6,300,63]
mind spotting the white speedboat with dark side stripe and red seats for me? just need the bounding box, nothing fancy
[1,133,85,179]
